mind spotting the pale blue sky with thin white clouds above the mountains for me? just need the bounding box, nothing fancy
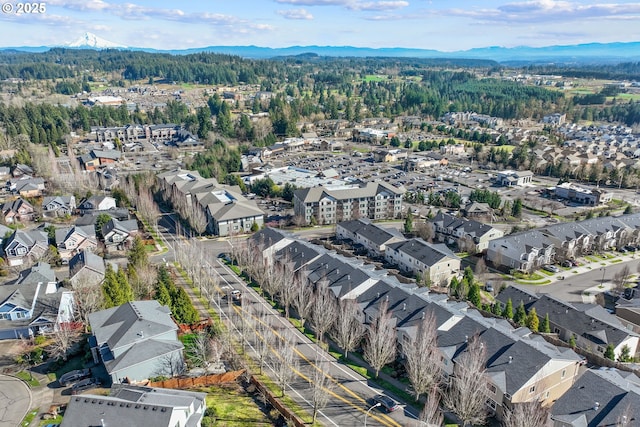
[0,0,640,51]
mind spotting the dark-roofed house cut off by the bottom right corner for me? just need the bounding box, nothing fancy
[550,368,640,427]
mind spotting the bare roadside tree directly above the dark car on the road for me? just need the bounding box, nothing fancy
[363,301,396,378]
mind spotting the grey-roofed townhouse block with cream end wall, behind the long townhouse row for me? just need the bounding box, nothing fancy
[384,239,460,285]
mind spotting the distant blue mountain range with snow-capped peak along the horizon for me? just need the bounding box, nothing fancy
[0,33,640,64]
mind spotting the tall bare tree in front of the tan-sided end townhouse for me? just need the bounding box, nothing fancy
[443,335,487,426]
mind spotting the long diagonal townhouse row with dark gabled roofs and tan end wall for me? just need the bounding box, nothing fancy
[249,228,582,417]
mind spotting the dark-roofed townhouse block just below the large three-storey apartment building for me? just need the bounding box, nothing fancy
[336,219,405,257]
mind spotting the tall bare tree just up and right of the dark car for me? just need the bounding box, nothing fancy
[402,311,442,400]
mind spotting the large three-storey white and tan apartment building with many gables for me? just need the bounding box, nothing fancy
[293,182,405,224]
